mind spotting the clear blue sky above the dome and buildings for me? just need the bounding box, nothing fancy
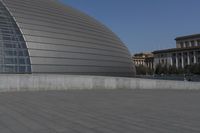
[60,0,200,53]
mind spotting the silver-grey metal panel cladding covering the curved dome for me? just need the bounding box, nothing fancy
[2,0,135,76]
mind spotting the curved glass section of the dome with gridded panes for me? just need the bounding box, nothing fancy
[0,2,31,73]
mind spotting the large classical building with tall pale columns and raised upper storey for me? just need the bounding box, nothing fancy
[153,34,200,68]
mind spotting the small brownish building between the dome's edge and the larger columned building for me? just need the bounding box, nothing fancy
[133,53,154,69]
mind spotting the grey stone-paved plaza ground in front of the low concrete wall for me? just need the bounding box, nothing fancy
[0,90,200,133]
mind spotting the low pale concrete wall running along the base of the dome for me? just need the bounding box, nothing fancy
[0,74,200,92]
